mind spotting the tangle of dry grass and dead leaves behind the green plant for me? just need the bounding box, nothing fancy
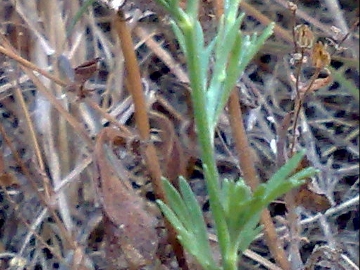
[0,0,359,269]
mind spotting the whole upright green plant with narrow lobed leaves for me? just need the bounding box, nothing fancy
[157,0,316,270]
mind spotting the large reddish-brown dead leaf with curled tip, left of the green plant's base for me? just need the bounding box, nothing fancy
[94,128,158,269]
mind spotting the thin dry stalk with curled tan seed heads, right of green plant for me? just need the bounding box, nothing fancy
[277,2,338,269]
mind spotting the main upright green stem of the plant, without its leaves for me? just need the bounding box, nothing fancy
[182,24,236,270]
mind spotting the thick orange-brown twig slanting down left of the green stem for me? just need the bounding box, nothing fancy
[114,10,189,270]
